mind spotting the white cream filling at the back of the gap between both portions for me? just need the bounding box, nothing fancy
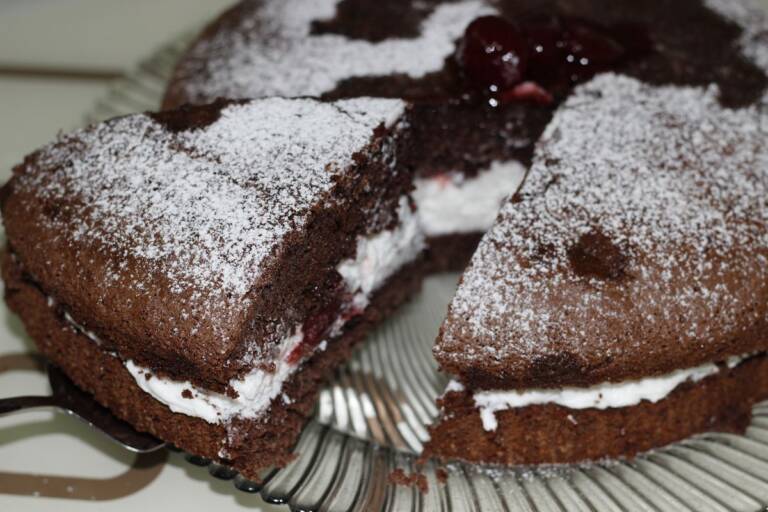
[413,161,525,236]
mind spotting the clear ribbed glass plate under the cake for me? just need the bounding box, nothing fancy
[81,37,768,512]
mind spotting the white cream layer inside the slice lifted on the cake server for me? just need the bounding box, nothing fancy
[125,197,425,423]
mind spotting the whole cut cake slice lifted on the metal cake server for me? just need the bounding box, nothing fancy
[2,99,424,478]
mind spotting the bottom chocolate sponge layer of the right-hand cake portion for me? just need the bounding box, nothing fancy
[424,354,768,465]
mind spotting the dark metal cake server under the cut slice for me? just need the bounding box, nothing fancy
[0,364,166,453]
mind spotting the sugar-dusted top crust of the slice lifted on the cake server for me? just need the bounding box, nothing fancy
[3,98,404,372]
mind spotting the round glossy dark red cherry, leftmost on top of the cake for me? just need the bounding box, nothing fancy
[458,16,528,92]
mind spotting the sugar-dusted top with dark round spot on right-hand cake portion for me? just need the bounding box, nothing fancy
[435,75,768,387]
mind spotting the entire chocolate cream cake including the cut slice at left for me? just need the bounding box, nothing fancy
[3,0,768,476]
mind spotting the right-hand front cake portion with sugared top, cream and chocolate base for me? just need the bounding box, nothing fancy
[426,74,768,464]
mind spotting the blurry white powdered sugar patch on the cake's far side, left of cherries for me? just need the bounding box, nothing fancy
[180,0,495,101]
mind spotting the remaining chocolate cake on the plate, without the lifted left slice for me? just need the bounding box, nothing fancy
[159,0,768,463]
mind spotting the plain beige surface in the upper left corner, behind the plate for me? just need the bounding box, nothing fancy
[0,0,233,175]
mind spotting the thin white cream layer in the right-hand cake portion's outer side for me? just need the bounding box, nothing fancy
[446,354,754,431]
